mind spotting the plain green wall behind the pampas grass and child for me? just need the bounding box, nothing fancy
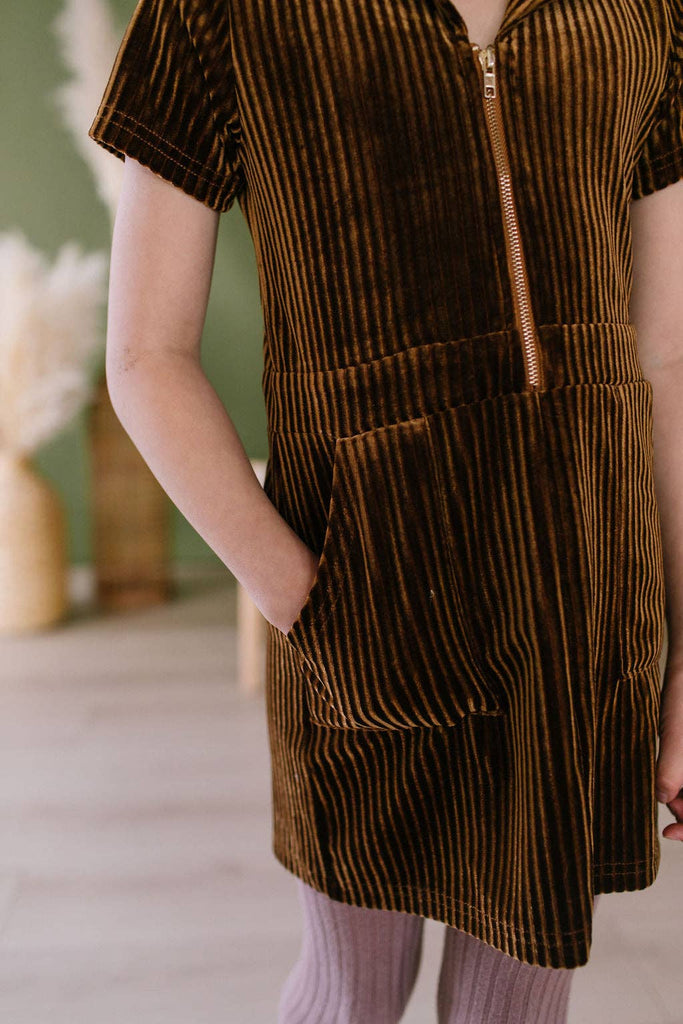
[0,0,267,565]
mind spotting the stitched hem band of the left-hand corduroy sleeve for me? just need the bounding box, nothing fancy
[88,106,243,213]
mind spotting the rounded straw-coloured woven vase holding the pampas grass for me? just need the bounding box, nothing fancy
[0,455,69,634]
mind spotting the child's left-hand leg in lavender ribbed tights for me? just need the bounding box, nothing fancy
[278,879,424,1024]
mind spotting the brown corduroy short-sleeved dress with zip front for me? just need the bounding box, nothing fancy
[89,0,683,968]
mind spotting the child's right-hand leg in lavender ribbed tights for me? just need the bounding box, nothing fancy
[437,895,599,1024]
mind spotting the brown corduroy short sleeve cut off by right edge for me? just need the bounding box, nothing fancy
[631,0,683,200]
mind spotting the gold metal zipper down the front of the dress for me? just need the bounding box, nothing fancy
[471,43,541,387]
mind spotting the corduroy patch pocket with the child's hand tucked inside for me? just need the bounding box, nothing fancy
[286,417,505,729]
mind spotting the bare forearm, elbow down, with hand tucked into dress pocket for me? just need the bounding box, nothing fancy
[108,351,310,629]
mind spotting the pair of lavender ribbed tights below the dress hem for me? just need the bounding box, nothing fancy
[278,878,599,1024]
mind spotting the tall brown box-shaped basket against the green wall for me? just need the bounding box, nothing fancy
[88,374,173,609]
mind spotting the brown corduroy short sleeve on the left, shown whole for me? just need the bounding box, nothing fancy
[88,0,245,213]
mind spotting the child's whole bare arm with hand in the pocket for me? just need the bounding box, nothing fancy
[106,157,317,632]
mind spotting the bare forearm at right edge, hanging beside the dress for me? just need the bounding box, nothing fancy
[645,359,683,671]
